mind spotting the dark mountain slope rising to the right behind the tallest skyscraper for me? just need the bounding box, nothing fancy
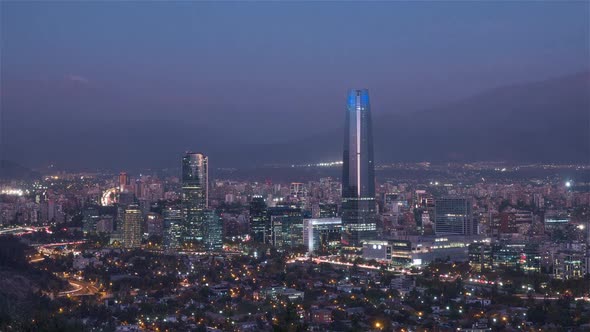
[242,72,590,163]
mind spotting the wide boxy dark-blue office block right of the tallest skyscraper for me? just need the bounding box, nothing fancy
[434,197,477,235]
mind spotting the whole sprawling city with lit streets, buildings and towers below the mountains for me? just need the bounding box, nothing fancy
[0,90,590,332]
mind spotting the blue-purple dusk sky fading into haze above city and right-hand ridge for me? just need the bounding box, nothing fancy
[0,1,590,168]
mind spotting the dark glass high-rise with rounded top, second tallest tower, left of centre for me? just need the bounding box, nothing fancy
[182,152,209,242]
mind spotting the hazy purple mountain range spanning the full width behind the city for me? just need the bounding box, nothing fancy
[0,72,590,171]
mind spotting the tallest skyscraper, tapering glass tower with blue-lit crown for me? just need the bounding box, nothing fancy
[342,90,377,247]
